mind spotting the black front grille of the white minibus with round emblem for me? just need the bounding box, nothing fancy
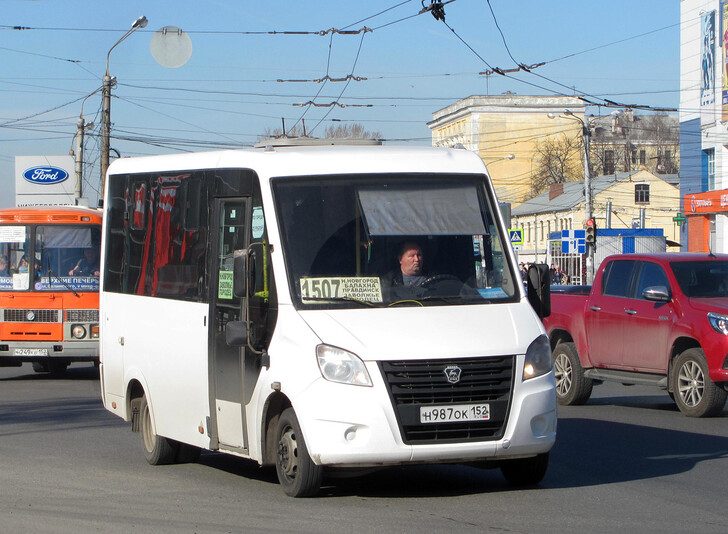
[379,356,516,444]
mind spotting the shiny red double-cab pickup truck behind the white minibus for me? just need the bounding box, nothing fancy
[544,253,728,417]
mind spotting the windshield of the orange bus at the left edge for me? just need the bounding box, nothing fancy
[0,224,101,291]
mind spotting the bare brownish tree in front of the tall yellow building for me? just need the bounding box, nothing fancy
[531,135,584,196]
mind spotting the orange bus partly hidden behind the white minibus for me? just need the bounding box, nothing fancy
[0,206,101,375]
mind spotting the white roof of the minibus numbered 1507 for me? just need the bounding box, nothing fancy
[109,146,485,179]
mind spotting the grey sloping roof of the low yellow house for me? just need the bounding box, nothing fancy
[511,170,673,217]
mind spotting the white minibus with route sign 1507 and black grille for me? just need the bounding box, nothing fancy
[100,146,556,496]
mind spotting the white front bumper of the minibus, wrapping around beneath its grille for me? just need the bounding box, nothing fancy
[294,374,556,467]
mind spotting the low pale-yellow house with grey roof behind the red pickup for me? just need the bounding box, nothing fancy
[511,170,680,268]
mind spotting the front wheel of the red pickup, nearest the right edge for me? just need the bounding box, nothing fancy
[671,348,728,417]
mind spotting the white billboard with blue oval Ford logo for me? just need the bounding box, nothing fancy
[15,156,76,207]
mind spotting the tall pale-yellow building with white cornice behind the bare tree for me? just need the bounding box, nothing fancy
[428,94,585,205]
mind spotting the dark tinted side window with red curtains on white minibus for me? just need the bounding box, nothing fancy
[105,171,210,301]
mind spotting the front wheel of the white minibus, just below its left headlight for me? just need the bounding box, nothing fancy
[276,408,323,497]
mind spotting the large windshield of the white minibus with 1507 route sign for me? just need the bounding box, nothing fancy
[273,174,520,308]
